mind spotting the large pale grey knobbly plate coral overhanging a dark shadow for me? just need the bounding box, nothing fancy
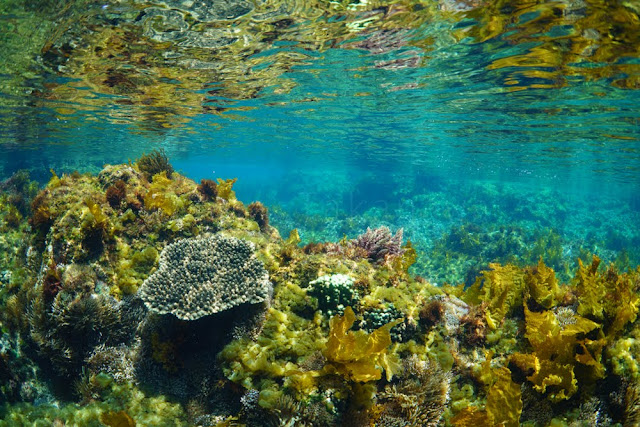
[140,235,272,320]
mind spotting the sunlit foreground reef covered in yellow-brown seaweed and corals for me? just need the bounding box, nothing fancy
[0,159,640,426]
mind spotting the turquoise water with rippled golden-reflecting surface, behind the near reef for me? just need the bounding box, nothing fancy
[0,0,640,282]
